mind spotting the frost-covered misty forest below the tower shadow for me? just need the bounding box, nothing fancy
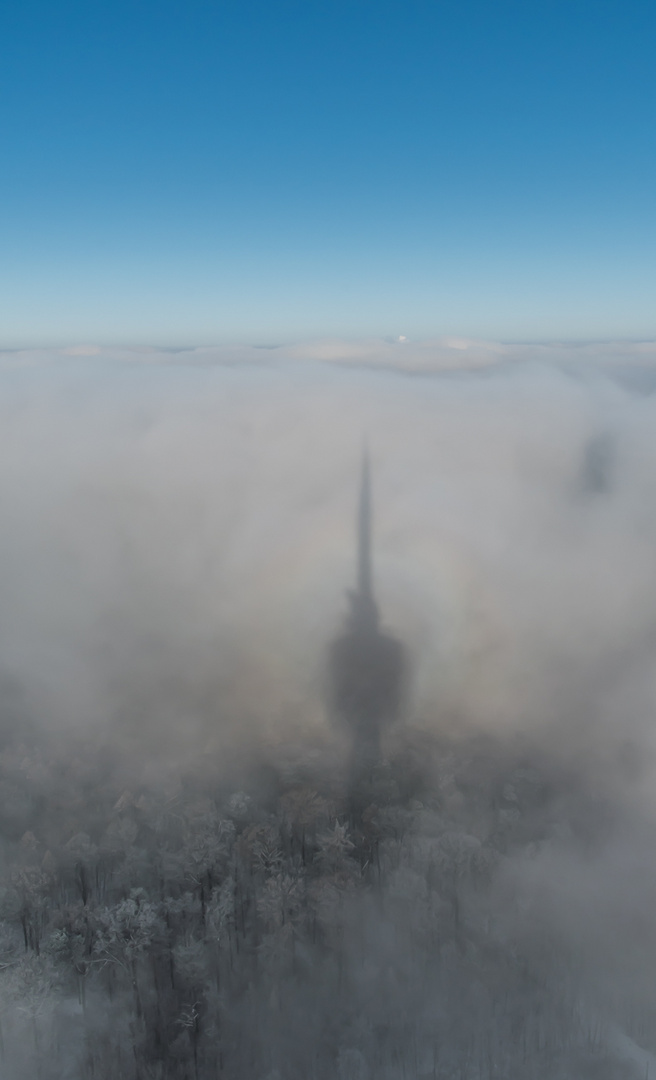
[0,712,654,1080]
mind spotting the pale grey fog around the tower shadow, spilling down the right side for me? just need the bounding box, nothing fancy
[0,341,656,1076]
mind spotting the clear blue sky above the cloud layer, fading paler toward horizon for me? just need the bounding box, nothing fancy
[0,0,656,347]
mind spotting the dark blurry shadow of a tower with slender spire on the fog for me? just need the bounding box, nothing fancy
[330,450,404,784]
